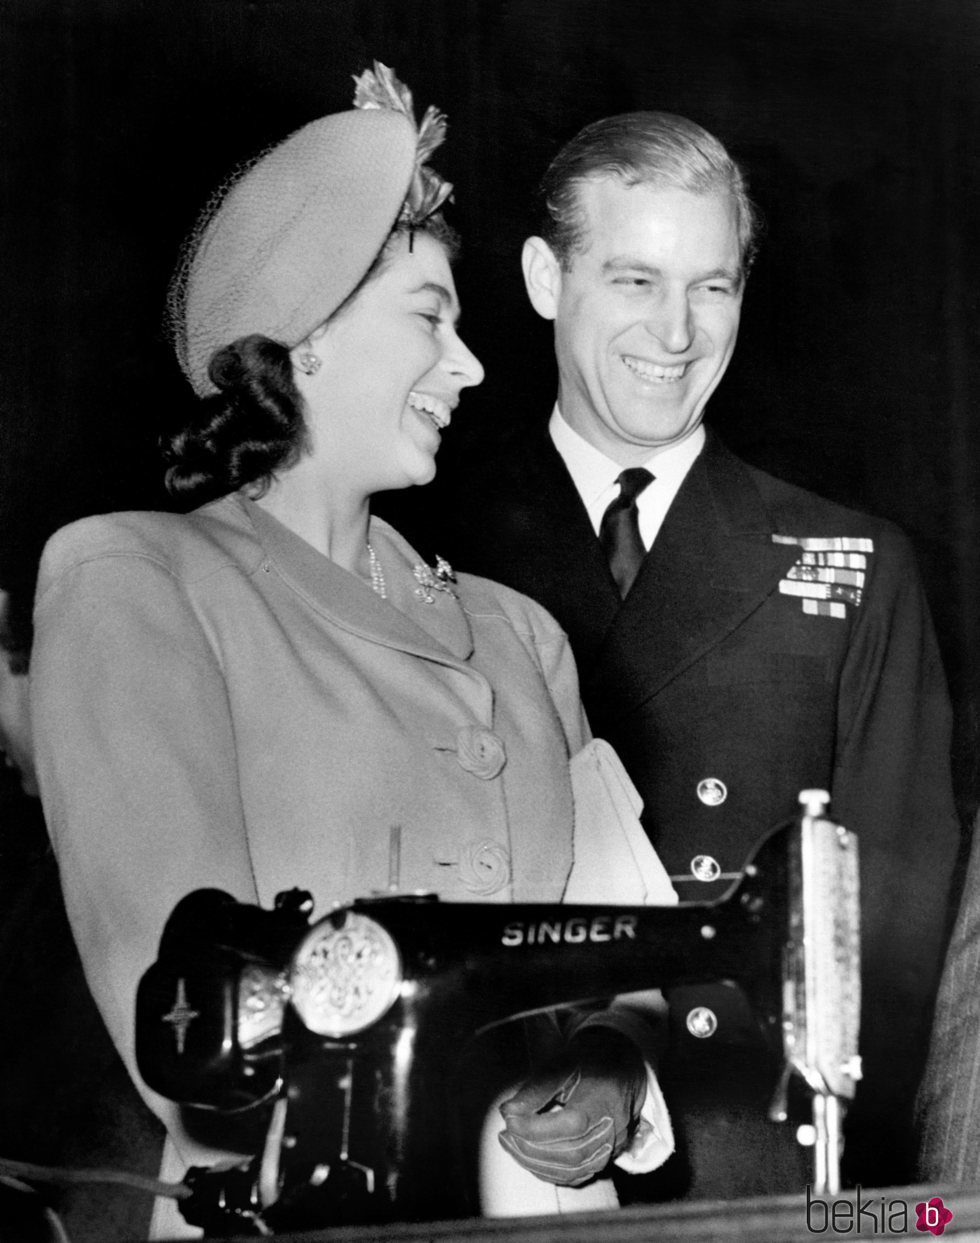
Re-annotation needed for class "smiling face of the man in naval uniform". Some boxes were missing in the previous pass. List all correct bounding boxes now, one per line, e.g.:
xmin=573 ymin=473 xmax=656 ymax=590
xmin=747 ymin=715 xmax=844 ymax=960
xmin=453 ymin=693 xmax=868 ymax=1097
xmin=525 ymin=178 xmax=742 ymax=466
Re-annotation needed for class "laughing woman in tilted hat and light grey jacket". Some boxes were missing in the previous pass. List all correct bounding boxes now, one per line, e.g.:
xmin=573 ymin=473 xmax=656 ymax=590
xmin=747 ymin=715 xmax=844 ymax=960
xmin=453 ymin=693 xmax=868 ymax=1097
xmin=26 ymin=55 xmax=672 ymax=1237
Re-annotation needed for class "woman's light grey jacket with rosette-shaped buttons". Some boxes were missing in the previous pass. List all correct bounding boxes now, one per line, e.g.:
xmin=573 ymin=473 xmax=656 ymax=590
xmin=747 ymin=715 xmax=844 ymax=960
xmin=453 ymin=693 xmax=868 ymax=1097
xmin=31 ymin=497 xmax=669 ymax=1233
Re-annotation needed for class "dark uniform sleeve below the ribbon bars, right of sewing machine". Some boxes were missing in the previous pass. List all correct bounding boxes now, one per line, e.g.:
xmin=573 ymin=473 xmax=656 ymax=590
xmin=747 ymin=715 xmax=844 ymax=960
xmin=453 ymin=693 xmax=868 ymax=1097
xmin=832 ymin=531 xmax=959 ymax=1148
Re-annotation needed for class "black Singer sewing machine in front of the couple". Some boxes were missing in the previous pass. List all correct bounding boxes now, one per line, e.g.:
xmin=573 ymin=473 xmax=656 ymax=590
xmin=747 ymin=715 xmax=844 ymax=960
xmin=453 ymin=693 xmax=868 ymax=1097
xmin=137 ymin=791 xmax=861 ymax=1233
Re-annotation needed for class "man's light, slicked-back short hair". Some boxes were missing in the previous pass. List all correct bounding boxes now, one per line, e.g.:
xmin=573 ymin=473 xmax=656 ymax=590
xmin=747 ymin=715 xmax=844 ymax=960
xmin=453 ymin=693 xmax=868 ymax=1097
xmin=539 ymin=112 xmax=760 ymax=276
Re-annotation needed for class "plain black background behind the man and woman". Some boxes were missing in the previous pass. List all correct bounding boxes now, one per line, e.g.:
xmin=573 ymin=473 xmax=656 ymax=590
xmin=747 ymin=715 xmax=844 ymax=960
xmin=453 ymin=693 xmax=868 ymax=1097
xmin=0 ymin=0 xmax=980 ymax=765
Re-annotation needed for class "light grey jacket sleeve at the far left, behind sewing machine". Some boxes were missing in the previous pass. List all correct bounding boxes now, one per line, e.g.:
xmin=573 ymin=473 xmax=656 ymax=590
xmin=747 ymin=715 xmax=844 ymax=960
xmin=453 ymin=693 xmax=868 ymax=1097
xmin=31 ymin=544 xmax=257 ymax=1114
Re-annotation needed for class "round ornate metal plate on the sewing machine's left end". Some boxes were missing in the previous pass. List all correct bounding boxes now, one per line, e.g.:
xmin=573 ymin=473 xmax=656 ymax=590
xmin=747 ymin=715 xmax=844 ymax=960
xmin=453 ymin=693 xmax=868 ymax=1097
xmin=290 ymin=911 xmax=402 ymax=1038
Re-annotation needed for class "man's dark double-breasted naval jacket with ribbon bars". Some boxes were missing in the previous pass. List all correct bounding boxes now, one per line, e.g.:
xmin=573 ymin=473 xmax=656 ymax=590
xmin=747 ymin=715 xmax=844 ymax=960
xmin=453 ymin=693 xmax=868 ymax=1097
xmin=417 ymin=425 xmax=959 ymax=1195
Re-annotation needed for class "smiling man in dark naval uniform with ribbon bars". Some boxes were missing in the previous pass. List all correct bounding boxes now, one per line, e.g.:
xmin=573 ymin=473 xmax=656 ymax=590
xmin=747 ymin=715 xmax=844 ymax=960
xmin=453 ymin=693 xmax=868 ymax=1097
xmin=430 ymin=112 xmax=958 ymax=1195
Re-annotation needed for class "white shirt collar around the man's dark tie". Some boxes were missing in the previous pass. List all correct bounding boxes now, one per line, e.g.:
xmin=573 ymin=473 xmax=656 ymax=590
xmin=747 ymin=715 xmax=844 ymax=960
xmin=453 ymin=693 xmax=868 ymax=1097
xmin=548 ymin=404 xmax=705 ymax=548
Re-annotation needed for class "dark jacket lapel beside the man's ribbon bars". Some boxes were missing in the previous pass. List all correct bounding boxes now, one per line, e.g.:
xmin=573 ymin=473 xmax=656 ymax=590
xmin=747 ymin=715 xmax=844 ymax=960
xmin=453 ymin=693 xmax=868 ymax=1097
xmin=588 ymin=436 xmax=798 ymax=715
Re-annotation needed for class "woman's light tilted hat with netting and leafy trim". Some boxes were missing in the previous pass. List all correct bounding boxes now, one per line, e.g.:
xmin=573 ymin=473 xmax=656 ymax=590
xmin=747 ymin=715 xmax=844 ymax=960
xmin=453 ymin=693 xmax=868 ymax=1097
xmin=168 ymin=62 xmax=451 ymax=397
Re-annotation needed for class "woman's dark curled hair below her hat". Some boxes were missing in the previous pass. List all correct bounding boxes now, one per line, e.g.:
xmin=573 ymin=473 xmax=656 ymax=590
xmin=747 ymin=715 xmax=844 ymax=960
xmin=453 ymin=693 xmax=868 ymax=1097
xmin=163 ymin=336 xmax=307 ymax=505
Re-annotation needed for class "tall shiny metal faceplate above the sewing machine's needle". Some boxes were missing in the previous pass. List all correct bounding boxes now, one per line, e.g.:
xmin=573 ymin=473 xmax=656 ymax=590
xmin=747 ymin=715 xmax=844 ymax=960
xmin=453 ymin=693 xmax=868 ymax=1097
xmin=784 ymin=815 xmax=861 ymax=1098
